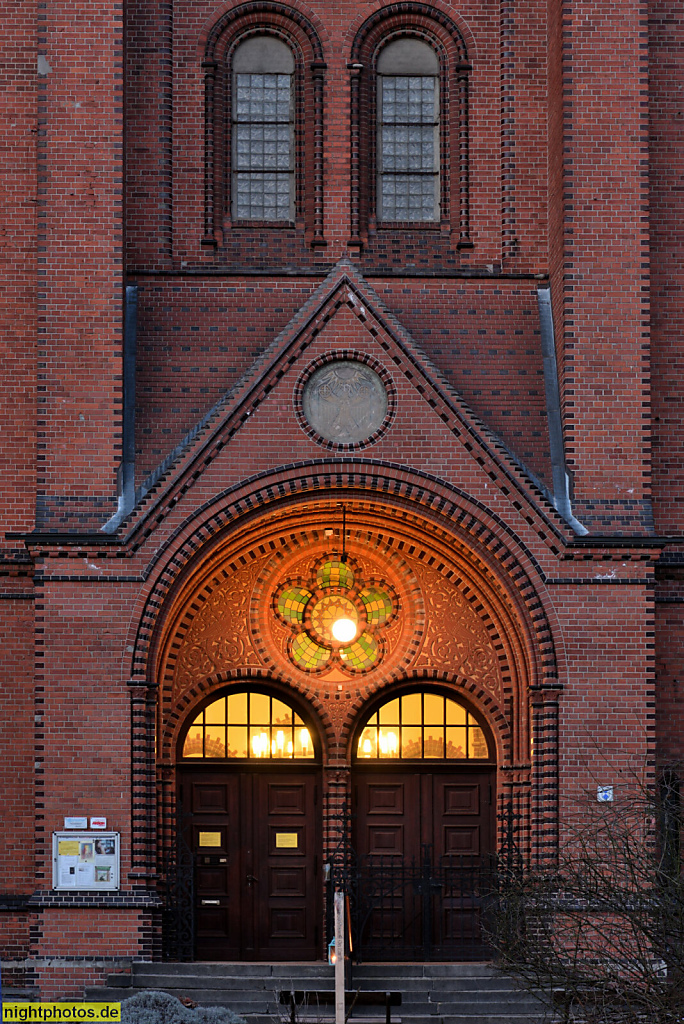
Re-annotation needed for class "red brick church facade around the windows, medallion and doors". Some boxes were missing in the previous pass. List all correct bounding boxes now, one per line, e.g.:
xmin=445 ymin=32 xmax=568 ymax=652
xmin=0 ymin=0 xmax=684 ymax=998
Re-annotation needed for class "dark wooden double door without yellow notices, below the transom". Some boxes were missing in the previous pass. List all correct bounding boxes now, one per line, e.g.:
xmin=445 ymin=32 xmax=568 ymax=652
xmin=353 ymin=766 xmax=495 ymax=961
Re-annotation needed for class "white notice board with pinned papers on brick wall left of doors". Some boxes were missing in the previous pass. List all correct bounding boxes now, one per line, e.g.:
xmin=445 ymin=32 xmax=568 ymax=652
xmin=52 ymin=831 xmax=120 ymax=892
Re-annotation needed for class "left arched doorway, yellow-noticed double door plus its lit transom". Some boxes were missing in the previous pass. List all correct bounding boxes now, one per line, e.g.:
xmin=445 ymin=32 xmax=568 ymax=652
xmin=177 ymin=684 xmax=322 ymax=961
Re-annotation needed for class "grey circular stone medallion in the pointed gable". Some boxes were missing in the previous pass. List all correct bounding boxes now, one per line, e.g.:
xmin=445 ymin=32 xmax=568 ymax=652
xmin=302 ymin=359 xmax=387 ymax=444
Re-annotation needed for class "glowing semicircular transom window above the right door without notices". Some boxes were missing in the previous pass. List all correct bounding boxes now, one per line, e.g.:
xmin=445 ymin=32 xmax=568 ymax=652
xmin=356 ymin=692 xmax=489 ymax=761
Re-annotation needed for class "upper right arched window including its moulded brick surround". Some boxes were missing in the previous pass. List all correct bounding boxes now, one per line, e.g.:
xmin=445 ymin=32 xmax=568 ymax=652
xmin=347 ymin=7 xmax=472 ymax=247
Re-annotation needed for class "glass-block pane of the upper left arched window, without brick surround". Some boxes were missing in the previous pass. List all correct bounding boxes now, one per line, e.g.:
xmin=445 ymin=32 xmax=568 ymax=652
xmin=231 ymin=36 xmax=295 ymax=221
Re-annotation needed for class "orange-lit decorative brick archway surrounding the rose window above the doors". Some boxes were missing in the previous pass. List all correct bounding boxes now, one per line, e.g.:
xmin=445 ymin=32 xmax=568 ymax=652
xmin=125 ymin=468 xmax=558 ymax=913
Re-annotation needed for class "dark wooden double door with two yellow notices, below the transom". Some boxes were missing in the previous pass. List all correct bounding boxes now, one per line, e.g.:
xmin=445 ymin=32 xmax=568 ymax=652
xmin=179 ymin=766 xmax=322 ymax=961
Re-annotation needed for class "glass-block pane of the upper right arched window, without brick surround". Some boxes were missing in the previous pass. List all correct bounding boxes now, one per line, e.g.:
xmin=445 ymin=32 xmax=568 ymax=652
xmin=376 ymin=37 xmax=439 ymax=221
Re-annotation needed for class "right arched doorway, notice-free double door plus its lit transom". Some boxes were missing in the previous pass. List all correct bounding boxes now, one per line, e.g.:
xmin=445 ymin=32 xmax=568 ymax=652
xmin=351 ymin=683 xmax=497 ymax=961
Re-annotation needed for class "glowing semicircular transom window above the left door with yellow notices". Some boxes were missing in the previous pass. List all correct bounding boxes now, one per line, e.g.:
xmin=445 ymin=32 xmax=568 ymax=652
xmin=182 ymin=692 xmax=315 ymax=761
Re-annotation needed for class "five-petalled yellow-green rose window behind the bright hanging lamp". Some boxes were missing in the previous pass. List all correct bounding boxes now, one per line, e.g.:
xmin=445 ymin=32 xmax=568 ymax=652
xmin=275 ymin=558 xmax=395 ymax=672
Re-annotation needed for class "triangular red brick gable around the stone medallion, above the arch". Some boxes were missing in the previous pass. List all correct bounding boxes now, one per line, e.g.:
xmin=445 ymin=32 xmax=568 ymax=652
xmin=117 ymin=259 xmax=573 ymax=544
